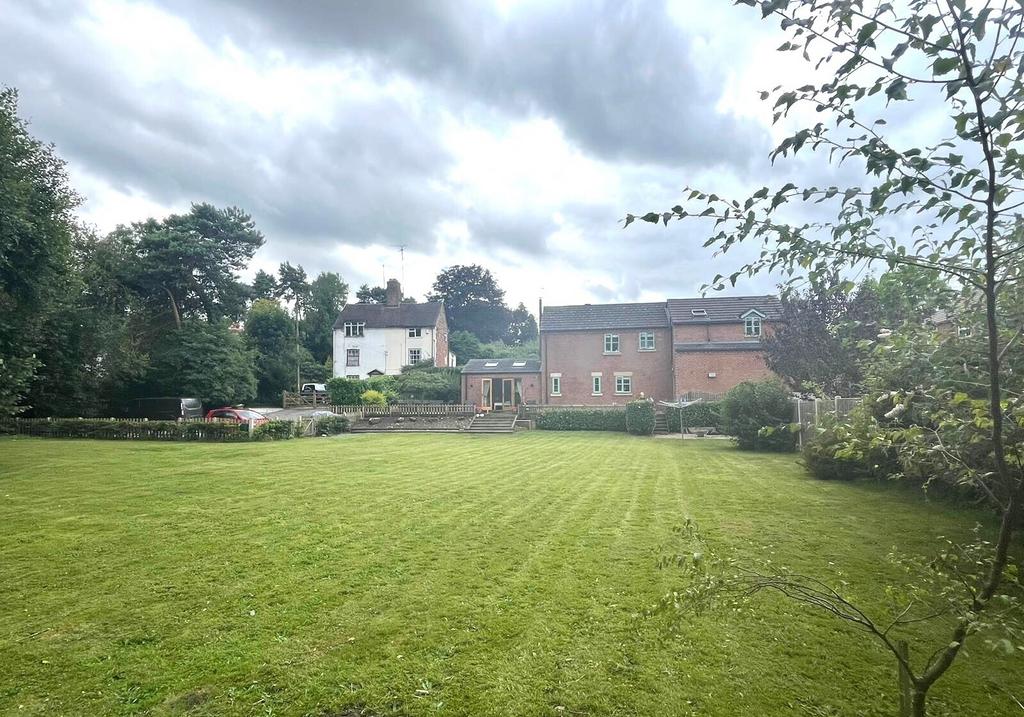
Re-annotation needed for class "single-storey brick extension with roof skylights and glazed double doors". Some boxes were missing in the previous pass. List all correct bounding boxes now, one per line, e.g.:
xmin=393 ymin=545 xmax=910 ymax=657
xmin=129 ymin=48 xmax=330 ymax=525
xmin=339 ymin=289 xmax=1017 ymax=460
xmin=462 ymin=359 xmax=543 ymax=411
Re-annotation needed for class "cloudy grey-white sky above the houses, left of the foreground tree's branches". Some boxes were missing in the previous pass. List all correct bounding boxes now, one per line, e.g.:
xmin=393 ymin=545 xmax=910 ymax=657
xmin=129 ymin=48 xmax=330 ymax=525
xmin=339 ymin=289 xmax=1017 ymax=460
xmin=0 ymin=0 xmax=847 ymax=307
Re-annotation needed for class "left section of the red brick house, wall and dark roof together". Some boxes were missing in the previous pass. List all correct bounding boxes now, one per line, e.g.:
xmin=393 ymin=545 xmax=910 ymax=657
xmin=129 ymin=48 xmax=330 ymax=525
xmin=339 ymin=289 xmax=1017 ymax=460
xmin=541 ymin=301 xmax=673 ymax=406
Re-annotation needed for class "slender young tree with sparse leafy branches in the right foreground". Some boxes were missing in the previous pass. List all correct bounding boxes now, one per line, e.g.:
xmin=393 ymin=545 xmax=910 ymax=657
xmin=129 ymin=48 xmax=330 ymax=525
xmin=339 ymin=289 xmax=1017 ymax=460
xmin=626 ymin=0 xmax=1024 ymax=717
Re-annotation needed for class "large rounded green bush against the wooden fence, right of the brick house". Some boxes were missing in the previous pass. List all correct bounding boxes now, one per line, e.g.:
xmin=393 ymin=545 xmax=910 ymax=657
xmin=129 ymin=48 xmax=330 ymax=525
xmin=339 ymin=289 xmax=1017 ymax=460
xmin=721 ymin=381 xmax=797 ymax=451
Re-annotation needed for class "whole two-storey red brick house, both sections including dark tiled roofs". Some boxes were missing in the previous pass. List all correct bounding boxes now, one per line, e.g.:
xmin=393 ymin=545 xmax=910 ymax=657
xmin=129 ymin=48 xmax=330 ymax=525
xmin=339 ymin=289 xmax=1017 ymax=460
xmin=540 ymin=296 xmax=781 ymax=406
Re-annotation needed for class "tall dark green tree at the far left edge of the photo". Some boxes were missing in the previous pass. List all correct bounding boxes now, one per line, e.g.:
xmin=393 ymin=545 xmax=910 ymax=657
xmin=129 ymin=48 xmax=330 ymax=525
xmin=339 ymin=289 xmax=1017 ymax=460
xmin=0 ymin=88 xmax=79 ymax=416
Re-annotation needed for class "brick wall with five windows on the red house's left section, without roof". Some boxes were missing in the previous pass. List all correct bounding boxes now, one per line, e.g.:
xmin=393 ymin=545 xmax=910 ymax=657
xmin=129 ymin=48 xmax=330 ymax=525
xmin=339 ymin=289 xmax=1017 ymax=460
xmin=541 ymin=328 xmax=673 ymax=406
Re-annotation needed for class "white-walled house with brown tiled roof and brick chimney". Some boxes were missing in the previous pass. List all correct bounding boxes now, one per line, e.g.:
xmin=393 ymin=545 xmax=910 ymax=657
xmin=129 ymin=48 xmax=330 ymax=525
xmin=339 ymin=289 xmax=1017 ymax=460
xmin=334 ymin=279 xmax=455 ymax=379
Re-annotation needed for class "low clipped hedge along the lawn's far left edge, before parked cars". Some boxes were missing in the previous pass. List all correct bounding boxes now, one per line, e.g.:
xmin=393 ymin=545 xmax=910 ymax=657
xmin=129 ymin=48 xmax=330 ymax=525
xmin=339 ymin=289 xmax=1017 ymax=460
xmin=0 ymin=416 xmax=349 ymax=442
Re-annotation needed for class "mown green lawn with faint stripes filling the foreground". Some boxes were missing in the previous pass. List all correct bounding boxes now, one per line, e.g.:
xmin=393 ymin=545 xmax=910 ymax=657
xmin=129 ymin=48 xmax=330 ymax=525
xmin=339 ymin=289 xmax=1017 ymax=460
xmin=0 ymin=432 xmax=1024 ymax=717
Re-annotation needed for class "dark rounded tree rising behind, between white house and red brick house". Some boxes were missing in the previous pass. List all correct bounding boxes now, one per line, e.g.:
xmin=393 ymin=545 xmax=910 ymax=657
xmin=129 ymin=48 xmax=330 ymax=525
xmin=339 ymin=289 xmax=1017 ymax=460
xmin=428 ymin=264 xmax=511 ymax=342
